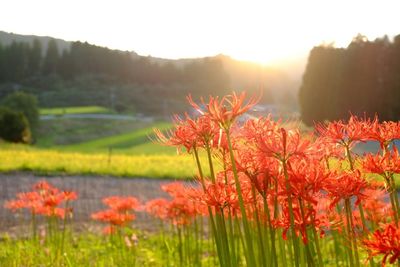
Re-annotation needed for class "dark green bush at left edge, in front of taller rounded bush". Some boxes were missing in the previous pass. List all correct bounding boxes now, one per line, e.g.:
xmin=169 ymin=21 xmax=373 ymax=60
xmin=0 ymin=107 xmax=31 ymax=143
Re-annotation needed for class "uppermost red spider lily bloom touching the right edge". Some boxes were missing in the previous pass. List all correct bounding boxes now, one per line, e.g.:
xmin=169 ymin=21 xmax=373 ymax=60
xmin=368 ymin=117 xmax=400 ymax=149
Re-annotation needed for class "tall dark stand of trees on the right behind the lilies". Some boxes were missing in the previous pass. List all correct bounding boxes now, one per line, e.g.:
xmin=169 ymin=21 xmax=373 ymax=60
xmin=299 ymin=35 xmax=400 ymax=125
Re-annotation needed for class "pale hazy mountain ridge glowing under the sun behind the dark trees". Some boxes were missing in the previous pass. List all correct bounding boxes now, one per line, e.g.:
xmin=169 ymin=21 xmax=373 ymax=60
xmin=0 ymin=31 xmax=306 ymax=102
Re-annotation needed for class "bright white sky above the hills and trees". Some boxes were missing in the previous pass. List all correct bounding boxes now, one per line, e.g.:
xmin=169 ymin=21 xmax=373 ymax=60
xmin=0 ymin=0 xmax=400 ymax=65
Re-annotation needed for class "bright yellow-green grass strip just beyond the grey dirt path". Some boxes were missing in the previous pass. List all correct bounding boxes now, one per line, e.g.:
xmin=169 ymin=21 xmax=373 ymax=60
xmin=0 ymin=144 xmax=202 ymax=179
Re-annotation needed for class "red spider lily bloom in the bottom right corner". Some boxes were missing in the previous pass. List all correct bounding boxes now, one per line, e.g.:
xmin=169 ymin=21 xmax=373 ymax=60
xmin=362 ymin=223 xmax=400 ymax=266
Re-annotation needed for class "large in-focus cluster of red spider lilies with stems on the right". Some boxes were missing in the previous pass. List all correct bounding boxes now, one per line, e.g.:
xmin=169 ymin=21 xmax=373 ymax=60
xmin=155 ymin=93 xmax=400 ymax=265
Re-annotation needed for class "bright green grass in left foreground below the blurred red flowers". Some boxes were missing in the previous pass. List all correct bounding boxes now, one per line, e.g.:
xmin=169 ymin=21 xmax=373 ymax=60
xmin=0 ymin=227 xmax=216 ymax=267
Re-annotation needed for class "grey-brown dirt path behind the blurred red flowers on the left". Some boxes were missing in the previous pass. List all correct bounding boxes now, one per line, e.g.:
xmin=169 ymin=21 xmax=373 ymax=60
xmin=0 ymin=173 xmax=181 ymax=230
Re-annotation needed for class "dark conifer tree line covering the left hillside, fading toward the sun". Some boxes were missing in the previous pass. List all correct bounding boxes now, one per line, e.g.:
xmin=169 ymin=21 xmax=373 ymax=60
xmin=0 ymin=39 xmax=230 ymax=113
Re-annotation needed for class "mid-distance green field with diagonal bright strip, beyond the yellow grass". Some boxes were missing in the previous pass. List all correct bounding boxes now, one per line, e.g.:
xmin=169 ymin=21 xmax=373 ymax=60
xmin=35 ymin=119 xmax=176 ymax=155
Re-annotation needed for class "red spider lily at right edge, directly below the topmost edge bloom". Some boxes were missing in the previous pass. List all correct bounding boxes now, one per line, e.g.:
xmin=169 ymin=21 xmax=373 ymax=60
xmin=362 ymin=147 xmax=400 ymax=176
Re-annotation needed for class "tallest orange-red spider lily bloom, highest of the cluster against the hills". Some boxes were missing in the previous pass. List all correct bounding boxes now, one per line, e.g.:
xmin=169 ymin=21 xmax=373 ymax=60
xmin=187 ymin=92 xmax=258 ymax=130
